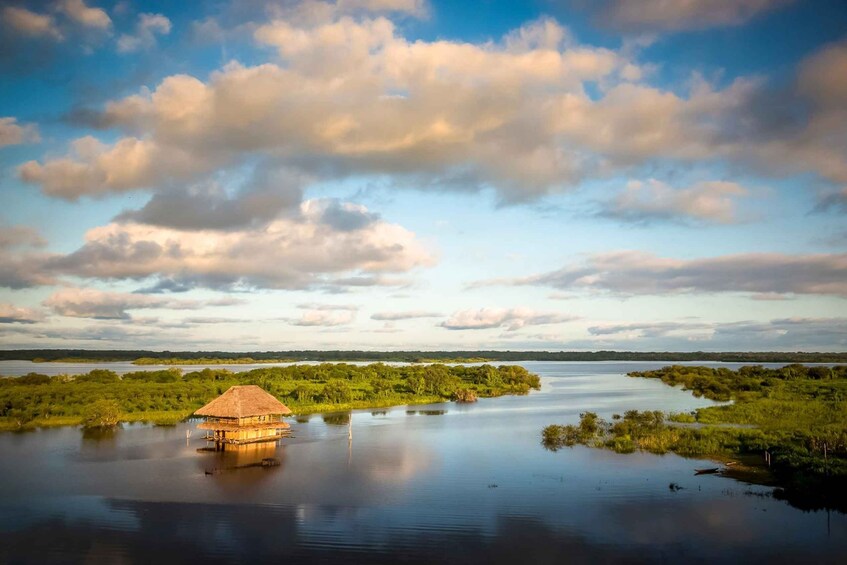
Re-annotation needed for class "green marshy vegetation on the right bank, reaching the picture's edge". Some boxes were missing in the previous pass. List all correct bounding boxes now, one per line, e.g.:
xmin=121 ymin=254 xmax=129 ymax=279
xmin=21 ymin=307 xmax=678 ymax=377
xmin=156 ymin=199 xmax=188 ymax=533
xmin=542 ymin=365 xmax=847 ymax=512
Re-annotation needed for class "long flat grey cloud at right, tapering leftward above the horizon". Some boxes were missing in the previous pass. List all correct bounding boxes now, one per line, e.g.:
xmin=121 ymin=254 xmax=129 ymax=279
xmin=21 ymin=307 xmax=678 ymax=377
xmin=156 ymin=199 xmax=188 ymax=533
xmin=494 ymin=251 xmax=847 ymax=297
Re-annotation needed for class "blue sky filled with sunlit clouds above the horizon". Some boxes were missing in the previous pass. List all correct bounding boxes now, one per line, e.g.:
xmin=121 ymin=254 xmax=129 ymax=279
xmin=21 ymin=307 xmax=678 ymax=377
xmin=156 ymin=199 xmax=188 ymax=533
xmin=0 ymin=0 xmax=847 ymax=351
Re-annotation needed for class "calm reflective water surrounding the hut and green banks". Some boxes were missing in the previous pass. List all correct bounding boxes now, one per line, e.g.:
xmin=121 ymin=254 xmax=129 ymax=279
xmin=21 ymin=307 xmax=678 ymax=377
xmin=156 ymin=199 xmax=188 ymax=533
xmin=0 ymin=362 xmax=847 ymax=564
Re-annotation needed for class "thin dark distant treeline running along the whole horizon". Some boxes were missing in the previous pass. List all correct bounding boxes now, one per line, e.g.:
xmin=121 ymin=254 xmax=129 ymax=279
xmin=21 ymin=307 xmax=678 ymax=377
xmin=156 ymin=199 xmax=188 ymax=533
xmin=6 ymin=349 xmax=847 ymax=363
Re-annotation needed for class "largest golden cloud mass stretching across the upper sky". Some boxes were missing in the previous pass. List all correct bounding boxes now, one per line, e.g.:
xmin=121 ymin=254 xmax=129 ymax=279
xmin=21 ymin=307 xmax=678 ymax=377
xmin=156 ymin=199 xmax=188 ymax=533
xmin=19 ymin=16 xmax=847 ymax=205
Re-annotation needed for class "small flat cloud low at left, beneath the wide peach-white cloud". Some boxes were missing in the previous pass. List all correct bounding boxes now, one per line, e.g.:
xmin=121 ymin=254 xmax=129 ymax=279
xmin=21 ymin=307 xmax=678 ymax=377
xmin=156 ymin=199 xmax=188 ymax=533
xmin=43 ymin=288 xmax=238 ymax=320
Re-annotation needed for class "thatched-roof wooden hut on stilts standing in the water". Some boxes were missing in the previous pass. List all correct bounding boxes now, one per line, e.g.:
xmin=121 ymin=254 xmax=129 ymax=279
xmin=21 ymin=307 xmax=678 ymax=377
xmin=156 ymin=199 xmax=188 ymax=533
xmin=194 ymin=385 xmax=291 ymax=445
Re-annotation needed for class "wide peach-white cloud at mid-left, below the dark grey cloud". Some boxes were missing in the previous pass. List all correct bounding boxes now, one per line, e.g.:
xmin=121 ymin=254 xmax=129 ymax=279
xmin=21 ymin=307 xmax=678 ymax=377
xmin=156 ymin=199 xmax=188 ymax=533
xmin=34 ymin=201 xmax=433 ymax=289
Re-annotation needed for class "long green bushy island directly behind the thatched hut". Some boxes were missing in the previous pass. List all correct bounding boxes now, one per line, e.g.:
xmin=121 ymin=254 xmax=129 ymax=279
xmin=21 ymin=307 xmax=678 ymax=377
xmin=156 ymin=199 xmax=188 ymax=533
xmin=0 ymin=363 xmax=541 ymax=431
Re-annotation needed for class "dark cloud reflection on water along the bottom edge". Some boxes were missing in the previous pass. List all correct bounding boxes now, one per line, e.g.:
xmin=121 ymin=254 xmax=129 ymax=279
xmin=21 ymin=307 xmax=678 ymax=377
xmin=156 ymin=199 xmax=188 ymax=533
xmin=0 ymin=499 xmax=836 ymax=564
